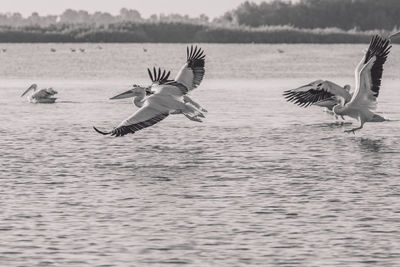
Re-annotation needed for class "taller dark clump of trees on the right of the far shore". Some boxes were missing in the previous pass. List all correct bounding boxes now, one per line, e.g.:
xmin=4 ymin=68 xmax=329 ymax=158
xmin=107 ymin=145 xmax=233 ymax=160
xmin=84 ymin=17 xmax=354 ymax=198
xmin=220 ymin=0 xmax=400 ymax=31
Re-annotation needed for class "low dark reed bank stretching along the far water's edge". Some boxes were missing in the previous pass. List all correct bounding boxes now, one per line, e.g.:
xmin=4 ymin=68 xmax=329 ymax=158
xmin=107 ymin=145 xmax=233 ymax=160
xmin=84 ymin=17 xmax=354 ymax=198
xmin=0 ymin=23 xmax=400 ymax=44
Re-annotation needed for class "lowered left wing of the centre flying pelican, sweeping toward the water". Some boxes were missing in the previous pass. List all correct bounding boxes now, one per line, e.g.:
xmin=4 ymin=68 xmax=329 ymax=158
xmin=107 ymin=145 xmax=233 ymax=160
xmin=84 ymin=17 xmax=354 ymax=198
xmin=93 ymin=104 xmax=169 ymax=137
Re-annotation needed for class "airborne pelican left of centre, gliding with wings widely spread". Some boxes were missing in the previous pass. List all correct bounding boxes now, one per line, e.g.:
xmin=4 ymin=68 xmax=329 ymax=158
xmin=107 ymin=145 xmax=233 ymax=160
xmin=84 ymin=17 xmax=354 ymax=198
xmin=93 ymin=46 xmax=205 ymax=136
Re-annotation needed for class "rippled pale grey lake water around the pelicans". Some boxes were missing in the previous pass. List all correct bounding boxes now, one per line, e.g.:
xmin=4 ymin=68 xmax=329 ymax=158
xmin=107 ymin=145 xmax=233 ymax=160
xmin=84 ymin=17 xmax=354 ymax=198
xmin=0 ymin=44 xmax=400 ymax=266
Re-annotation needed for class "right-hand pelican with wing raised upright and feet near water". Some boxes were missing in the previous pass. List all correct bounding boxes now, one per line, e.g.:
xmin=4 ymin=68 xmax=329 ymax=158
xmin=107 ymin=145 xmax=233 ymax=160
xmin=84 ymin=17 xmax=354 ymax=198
xmin=284 ymin=32 xmax=400 ymax=133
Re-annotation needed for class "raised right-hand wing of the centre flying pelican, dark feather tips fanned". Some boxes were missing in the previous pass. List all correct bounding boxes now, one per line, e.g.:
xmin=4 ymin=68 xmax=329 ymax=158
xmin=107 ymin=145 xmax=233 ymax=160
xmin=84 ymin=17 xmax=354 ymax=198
xmin=175 ymin=46 xmax=206 ymax=94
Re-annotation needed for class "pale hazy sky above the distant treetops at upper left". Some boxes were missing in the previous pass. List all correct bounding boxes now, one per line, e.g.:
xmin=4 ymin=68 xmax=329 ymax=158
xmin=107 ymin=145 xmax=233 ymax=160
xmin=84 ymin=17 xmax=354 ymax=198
xmin=0 ymin=0 xmax=268 ymax=18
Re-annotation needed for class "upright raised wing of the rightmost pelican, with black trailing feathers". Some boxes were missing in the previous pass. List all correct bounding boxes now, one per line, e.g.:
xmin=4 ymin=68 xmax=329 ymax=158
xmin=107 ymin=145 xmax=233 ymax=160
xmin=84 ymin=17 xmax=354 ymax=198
xmin=348 ymin=35 xmax=392 ymax=109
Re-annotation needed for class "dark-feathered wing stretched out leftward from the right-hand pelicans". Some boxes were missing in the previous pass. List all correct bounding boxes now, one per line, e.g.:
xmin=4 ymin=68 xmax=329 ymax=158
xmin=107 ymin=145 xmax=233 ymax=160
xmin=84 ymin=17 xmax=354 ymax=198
xmin=283 ymin=82 xmax=350 ymax=107
